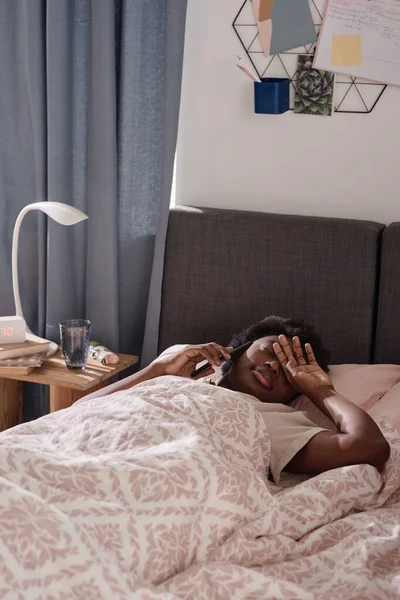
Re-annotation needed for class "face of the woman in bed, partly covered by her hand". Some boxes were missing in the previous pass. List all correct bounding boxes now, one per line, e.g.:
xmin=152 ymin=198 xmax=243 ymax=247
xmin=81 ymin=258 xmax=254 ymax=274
xmin=224 ymin=335 xmax=296 ymax=404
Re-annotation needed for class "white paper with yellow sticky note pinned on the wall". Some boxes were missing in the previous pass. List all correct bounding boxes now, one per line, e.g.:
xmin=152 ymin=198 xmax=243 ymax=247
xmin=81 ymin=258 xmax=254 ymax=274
xmin=314 ymin=0 xmax=400 ymax=85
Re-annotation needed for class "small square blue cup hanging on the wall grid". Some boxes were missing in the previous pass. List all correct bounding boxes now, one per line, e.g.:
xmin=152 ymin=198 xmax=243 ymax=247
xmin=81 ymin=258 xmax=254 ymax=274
xmin=254 ymin=77 xmax=290 ymax=115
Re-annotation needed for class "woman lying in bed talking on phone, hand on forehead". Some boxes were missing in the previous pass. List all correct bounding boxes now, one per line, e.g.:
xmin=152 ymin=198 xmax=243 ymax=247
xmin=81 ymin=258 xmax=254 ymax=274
xmin=86 ymin=317 xmax=390 ymax=483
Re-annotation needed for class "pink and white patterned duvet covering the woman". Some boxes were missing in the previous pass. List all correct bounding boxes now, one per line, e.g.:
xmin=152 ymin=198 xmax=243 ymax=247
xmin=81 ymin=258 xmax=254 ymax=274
xmin=0 ymin=377 xmax=400 ymax=600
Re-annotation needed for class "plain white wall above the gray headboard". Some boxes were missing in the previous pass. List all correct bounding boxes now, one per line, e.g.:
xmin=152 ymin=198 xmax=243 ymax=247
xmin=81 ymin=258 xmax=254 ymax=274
xmin=176 ymin=0 xmax=400 ymax=223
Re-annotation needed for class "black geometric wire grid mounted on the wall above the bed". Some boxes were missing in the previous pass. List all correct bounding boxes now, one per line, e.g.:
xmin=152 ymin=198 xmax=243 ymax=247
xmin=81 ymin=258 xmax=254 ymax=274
xmin=232 ymin=0 xmax=387 ymax=114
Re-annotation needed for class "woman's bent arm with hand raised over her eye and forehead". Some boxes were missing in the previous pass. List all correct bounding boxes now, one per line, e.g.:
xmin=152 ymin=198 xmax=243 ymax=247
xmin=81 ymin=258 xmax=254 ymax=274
xmin=274 ymin=336 xmax=390 ymax=473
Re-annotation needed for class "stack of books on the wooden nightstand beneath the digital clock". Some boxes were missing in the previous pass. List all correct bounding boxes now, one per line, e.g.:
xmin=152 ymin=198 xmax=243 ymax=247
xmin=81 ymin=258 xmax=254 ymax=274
xmin=0 ymin=341 xmax=49 ymax=377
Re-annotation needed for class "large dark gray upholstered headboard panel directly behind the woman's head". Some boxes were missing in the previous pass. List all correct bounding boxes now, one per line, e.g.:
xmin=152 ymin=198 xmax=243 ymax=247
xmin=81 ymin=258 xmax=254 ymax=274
xmin=159 ymin=207 xmax=384 ymax=363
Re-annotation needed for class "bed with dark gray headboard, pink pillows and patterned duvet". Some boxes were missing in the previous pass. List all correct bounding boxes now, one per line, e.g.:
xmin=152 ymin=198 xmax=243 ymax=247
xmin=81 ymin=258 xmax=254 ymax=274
xmin=0 ymin=208 xmax=400 ymax=600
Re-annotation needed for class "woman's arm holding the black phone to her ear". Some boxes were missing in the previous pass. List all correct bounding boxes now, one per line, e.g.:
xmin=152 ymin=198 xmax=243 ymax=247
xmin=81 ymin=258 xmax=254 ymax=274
xmin=81 ymin=342 xmax=232 ymax=400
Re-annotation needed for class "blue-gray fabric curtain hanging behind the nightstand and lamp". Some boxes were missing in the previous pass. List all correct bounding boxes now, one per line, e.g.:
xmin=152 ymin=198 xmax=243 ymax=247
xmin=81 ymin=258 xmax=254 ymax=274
xmin=0 ymin=0 xmax=186 ymax=420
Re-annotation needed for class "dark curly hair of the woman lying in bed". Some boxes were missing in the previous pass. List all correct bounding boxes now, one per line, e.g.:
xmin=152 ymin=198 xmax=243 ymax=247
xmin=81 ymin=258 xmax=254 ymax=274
xmin=222 ymin=316 xmax=329 ymax=375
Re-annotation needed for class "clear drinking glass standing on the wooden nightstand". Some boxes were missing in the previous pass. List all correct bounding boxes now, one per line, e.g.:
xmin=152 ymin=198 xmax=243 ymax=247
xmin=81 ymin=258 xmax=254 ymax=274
xmin=60 ymin=319 xmax=92 ymax=371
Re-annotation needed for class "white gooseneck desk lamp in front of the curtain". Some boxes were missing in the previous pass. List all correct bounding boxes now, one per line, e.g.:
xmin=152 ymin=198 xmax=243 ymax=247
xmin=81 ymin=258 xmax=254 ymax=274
xmin=7 ymin=202 xmax=88 ymax=356
